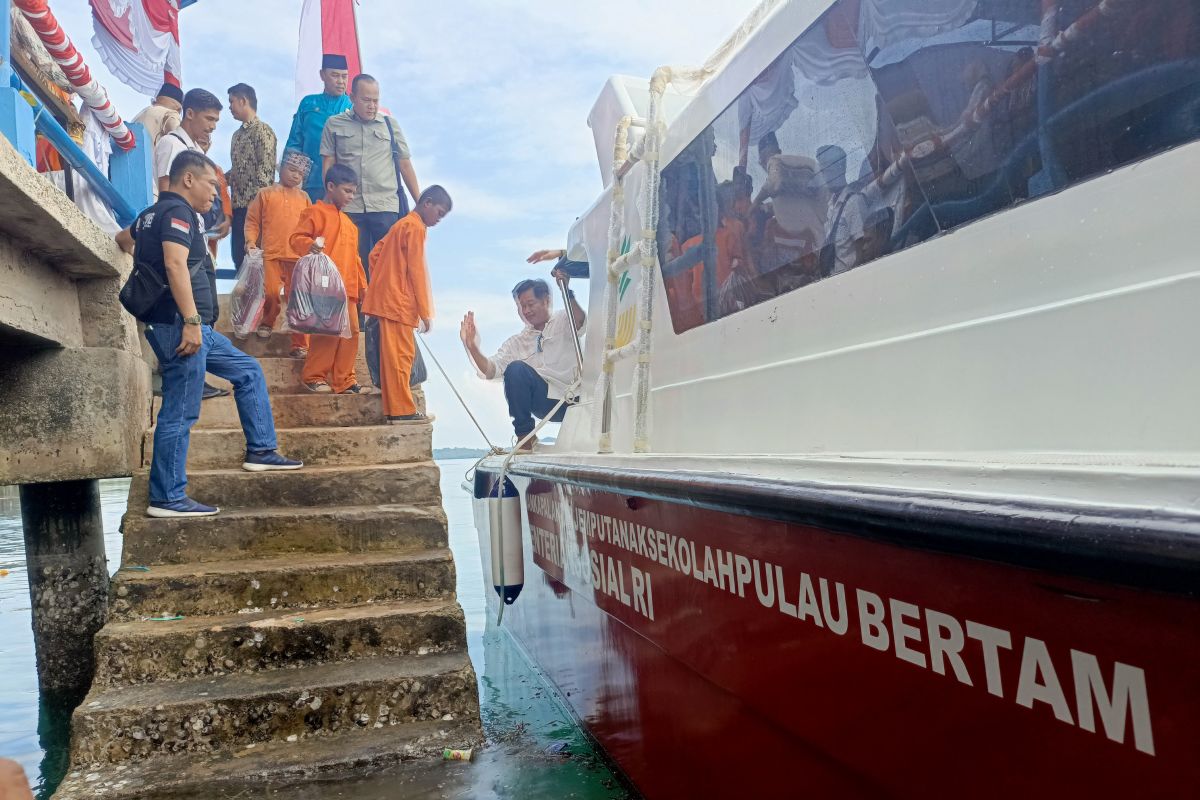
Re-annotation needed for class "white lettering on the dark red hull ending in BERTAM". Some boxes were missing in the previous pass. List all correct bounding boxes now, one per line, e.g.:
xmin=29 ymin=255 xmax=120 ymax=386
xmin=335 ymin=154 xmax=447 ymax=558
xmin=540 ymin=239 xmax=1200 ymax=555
xmin=549 ymin=503 xmax=1154 ymax=756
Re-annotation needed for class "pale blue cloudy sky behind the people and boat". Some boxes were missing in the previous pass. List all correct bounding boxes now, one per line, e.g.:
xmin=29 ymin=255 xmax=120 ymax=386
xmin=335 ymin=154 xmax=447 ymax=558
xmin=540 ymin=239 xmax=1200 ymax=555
xmin=50 ymin=0 xmax=757 ymax=447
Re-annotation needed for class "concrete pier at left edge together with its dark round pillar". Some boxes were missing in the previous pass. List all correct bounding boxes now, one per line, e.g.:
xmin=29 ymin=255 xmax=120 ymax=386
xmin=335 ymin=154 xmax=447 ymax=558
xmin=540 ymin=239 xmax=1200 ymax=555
xmin=0 ymin=134 xmax=151 ymax=694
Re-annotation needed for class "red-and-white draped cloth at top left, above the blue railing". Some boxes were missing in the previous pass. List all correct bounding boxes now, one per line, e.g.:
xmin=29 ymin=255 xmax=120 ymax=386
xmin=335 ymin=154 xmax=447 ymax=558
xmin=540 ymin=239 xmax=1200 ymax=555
xmin=89 ymin=0 xmax=184 ymax=97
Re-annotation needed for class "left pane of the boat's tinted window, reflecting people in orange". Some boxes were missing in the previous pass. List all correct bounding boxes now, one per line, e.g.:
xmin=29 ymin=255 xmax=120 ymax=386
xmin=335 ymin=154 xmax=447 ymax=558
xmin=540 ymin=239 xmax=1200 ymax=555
xmin=660 ymin=6 xmax=937 ymax=331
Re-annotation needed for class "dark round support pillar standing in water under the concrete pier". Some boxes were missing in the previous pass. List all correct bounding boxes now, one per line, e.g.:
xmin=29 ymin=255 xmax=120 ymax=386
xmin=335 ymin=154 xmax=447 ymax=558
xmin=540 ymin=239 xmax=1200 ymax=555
xmin=20 ymin=480 xmax=108 ymax=692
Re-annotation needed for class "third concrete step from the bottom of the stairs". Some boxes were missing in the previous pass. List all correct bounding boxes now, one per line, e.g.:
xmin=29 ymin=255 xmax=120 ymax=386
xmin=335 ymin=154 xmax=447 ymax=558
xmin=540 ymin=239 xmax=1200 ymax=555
xmin=92 ymin=600 xmax=467 ymax=686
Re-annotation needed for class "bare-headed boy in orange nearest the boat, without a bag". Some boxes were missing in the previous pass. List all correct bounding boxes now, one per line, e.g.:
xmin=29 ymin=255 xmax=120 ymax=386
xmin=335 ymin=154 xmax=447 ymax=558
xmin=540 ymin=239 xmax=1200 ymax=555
xmin=362 ymin=186 xmax=454 ymax=423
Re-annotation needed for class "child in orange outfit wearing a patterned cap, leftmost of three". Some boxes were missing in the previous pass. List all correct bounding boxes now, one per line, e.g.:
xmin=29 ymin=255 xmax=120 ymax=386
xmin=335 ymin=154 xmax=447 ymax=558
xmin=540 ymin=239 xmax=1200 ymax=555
xmin=246 ymin=150 xmax=312 ymax=359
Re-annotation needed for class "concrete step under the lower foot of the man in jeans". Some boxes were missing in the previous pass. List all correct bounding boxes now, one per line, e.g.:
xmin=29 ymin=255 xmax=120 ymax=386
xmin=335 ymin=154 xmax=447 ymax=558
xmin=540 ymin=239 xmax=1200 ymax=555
xmin=121 ymin=505 xmax=448 ymax=566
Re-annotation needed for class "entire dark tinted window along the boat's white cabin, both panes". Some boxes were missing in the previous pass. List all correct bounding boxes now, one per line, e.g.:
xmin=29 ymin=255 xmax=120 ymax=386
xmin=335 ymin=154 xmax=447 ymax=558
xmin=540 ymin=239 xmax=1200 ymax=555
xmin=659 ymin=0 xmax=1200 ymax=332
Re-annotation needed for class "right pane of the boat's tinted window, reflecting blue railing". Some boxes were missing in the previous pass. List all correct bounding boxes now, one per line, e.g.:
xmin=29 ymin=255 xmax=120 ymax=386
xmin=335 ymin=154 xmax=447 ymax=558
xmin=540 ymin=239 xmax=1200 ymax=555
xmin=860 ymin=0 xmax=1200 ymax=229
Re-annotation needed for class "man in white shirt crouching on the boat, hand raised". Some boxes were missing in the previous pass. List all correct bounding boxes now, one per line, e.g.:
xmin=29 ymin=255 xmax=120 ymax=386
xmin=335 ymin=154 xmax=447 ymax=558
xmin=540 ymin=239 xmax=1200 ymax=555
xmin=458 ymin=270 xmax=587 ymax=451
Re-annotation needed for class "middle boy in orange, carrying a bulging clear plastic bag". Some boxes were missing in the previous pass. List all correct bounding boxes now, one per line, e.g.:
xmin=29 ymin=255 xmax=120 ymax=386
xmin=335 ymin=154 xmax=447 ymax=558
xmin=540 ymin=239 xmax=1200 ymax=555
xmin=290 ymin=164 xmax=374 ymax=395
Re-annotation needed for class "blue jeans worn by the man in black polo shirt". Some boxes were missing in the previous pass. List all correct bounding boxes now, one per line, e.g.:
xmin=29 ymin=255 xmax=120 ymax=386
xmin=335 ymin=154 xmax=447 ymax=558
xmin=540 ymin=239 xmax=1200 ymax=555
xmin=146 ymin=318 xmax=278 ymax=503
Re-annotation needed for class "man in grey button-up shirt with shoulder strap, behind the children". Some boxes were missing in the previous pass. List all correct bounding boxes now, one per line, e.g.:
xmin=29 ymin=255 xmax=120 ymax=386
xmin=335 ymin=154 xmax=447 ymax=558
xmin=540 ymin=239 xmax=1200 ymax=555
xmin=320 ymin=73 xmax=425 ymax=386
